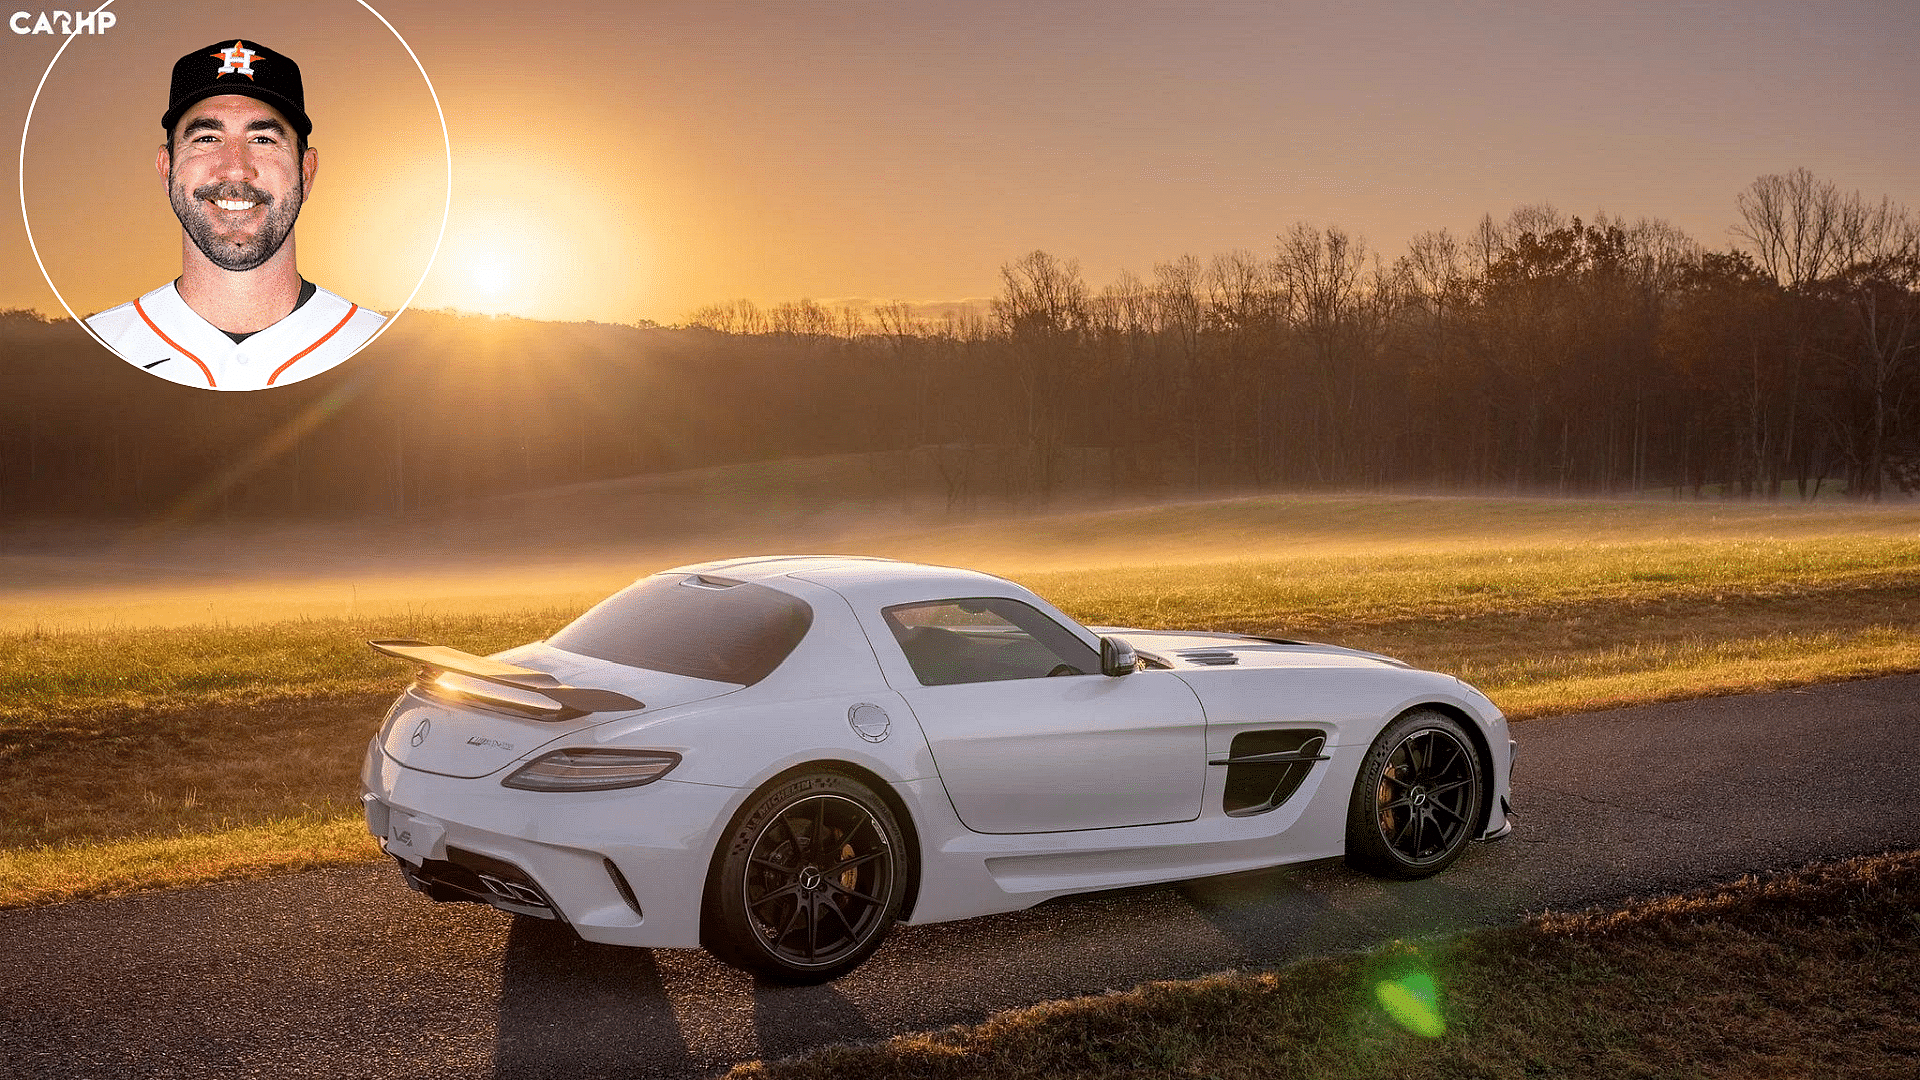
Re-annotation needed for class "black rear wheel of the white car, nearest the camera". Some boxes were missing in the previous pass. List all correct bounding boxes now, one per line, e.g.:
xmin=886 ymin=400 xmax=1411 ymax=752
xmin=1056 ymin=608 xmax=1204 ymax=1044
xmin=703 ymin=771 xmax=912 ymax=984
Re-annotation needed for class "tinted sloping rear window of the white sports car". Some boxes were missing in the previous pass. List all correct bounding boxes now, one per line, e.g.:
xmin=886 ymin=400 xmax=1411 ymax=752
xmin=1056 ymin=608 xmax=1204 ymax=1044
xmin=547 ymin=575 xmax=814 ymax=686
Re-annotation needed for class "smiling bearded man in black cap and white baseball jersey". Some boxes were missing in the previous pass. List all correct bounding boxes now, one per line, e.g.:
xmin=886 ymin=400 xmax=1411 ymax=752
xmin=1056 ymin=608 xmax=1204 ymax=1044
xmin=86 ymin=38 xmax=386 ymax=390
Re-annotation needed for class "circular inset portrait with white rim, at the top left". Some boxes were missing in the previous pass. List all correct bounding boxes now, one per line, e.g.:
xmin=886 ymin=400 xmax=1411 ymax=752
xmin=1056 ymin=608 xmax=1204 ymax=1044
xmin=21 ymin=0 xmax=451 ymax=390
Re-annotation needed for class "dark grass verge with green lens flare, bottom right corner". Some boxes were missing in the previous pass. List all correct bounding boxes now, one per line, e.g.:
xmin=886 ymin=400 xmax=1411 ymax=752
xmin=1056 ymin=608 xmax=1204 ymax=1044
xmin=730 ymin=853 xmax=1920 ymax=1080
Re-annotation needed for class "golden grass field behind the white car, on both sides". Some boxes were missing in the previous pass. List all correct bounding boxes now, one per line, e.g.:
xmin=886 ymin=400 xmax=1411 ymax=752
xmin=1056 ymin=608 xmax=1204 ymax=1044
xmin=0 ymin=496 xmax=1920 ymax=905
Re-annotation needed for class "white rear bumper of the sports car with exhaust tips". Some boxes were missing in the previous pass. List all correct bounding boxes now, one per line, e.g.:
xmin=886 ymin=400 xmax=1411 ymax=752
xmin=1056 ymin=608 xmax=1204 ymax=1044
xmin=361 ymin=734 xmax=743 ymax=947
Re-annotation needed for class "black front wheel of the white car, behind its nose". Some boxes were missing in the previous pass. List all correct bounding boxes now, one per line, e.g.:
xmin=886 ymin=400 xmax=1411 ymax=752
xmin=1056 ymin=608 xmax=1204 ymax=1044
xmin=1346 ymin=709 xmax=1486 ymax=880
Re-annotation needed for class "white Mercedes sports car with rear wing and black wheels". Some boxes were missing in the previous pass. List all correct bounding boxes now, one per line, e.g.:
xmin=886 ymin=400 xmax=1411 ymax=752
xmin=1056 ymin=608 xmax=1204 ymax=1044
xmin=363 ymin=555 xmax=1513 ymax=982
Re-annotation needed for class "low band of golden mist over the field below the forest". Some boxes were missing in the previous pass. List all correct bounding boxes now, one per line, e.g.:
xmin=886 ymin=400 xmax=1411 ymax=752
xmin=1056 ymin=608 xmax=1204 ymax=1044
xmin=0 ymin=468 xmax=1920 ymax=632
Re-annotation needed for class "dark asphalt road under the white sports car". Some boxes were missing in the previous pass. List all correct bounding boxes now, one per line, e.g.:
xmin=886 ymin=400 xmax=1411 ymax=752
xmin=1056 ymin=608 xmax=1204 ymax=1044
xmin=0 ymin=675 xmax=1920 ymax=1080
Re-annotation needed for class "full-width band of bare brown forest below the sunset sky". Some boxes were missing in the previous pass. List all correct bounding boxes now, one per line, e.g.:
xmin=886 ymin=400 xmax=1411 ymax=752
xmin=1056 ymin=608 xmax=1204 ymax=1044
xmin=0 ymin=169 xmax=1920 ymax=521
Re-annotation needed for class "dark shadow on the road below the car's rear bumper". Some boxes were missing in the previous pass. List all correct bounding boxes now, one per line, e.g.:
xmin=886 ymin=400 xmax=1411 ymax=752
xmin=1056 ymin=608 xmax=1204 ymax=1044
xmin=493 ymin=919 xmax=701 ymax=1080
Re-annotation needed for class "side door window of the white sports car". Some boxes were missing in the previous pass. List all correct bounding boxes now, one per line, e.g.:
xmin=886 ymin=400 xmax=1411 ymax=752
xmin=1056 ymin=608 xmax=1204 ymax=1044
xmin=881 ymin=596 xmax=1100 ymax=686
